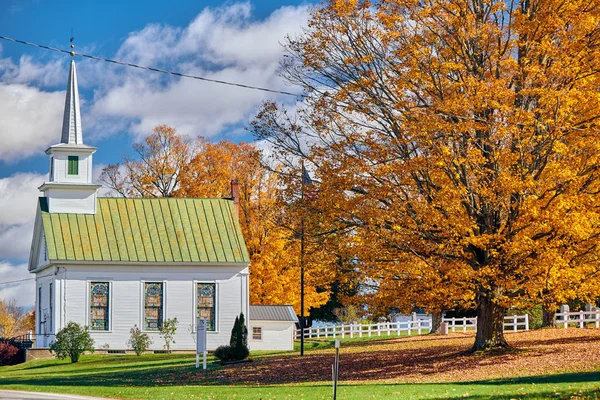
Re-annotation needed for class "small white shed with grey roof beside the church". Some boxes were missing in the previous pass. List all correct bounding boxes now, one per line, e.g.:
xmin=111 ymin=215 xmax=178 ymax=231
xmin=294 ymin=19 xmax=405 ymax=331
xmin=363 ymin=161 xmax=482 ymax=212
xmin=248 ymin=304 xmax=298 ymax=350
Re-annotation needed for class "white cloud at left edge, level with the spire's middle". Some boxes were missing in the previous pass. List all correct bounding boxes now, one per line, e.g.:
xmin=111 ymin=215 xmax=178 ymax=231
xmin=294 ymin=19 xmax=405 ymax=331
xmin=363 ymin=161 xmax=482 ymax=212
xmin=0 ymin=83 xmax=65 ymax=161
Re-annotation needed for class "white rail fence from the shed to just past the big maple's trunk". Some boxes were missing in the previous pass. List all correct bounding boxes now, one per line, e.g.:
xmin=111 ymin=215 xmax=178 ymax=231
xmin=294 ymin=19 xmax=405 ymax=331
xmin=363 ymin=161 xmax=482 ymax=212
xmin=296 ymin=314 xmax=529 ymax=339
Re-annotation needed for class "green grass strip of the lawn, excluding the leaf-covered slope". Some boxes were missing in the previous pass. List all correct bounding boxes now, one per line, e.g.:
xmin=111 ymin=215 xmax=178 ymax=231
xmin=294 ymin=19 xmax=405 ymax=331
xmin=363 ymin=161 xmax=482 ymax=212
xmin=0 ymin=354 xmax=600 ymax=400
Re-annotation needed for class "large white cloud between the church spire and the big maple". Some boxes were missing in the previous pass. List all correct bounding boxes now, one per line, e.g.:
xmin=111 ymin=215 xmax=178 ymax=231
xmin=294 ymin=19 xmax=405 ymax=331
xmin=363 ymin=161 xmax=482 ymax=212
xmin=92 ymin=3 xmax=309 ymax=137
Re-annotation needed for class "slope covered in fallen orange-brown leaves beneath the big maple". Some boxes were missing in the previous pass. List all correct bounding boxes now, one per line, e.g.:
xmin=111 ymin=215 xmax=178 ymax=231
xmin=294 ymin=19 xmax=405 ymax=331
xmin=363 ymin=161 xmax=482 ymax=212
xmin=204 ymin=329 xmax=600 ymax=384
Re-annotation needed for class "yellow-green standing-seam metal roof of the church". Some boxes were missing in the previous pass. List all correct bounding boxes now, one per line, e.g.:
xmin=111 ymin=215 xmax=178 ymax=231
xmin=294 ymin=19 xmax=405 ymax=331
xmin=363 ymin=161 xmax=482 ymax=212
xmin=40 ymin=197 xmax=250 ymax=263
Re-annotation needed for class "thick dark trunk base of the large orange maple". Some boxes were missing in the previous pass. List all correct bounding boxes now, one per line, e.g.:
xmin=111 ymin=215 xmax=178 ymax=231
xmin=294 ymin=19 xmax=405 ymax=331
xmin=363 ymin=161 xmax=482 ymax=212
xmin=471 ymin=292 xmax=509 ymax=352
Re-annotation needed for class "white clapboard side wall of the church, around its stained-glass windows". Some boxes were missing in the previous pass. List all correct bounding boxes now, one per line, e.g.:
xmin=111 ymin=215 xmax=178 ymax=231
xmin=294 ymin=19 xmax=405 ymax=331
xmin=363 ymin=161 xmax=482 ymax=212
xmin=37 ymin=265 xmax=248 ymax=350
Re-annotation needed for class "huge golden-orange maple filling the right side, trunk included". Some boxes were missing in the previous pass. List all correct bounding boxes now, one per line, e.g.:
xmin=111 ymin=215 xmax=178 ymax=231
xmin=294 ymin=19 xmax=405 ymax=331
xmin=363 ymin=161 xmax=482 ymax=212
xmin=255 ymin=0 xmax=600 ymax=350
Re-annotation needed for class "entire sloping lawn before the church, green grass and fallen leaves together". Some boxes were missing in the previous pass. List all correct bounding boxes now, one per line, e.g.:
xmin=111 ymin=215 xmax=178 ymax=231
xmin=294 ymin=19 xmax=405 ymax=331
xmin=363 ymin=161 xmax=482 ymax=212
xmin=0 ymin=329 xmax=600 ymax=399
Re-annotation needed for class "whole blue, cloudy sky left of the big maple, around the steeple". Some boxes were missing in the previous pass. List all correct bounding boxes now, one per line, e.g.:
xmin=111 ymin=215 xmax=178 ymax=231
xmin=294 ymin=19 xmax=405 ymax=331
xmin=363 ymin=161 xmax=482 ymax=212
xmin=0 ymin=0 xmax=311 ymax=305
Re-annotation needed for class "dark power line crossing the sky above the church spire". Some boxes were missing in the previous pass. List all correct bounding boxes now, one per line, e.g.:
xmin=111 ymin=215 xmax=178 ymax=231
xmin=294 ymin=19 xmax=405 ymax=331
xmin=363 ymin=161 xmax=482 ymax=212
xmin=0 ymin=35 xmax=302 ymax=98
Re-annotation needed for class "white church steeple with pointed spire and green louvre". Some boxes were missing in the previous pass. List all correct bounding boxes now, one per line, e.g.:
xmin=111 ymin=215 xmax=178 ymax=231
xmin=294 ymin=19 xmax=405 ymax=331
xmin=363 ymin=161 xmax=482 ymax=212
xmin=39 ymin=54 xmax=101 ymax=214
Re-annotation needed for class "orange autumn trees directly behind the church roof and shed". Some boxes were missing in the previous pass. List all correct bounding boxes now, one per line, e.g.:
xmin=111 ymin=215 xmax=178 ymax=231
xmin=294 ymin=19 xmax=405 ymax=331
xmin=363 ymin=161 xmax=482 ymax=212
xmin=101 ymin=125 xmax=328 ymax=312
